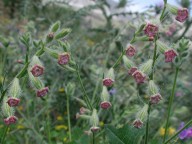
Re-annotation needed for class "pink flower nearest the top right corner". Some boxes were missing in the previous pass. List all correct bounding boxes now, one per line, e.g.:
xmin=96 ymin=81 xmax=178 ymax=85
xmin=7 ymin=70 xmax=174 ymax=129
xmin=175 ymin=8 xmax=189 ymax=22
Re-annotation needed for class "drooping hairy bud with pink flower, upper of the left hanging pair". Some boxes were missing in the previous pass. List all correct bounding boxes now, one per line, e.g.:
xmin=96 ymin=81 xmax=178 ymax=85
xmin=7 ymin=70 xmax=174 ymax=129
xmin=30 ymin=56 xmax=44 ymax=77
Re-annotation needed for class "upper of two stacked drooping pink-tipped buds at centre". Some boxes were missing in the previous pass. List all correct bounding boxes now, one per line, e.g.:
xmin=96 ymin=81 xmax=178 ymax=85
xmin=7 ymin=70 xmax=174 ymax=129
xmin=103 ymin=68 xmax=115 ymax=87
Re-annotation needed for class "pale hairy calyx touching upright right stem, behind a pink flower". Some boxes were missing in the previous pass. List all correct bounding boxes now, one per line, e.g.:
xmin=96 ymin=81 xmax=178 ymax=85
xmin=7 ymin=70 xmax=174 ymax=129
xmin=139 ymin=59 xmax=153 ymax=75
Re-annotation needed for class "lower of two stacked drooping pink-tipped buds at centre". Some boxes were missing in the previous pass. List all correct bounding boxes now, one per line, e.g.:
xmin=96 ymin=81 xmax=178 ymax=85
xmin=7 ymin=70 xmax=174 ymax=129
xmin=100 ymin=86 xmax=111 ymax=109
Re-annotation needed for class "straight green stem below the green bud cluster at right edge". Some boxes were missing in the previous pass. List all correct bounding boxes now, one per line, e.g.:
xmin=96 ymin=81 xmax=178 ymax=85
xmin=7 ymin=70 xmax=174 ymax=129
xmin=163 ymin=67 xmax=179 ymax=142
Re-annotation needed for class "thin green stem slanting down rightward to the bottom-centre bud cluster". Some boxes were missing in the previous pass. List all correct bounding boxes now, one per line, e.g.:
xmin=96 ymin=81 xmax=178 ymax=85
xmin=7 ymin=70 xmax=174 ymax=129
xmin=76 ymin=69 xmax=93 ymax=110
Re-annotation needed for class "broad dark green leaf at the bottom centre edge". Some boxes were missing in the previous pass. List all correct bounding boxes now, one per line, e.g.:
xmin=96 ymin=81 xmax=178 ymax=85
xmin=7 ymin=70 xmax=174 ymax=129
xmin=105 ymin=125 xmax=144 ymax=144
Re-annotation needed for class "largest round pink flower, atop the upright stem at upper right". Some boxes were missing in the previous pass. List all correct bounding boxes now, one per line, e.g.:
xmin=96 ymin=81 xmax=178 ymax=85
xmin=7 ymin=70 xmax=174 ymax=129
xmin=144 ymin=23 xmax=158 ymax=37
